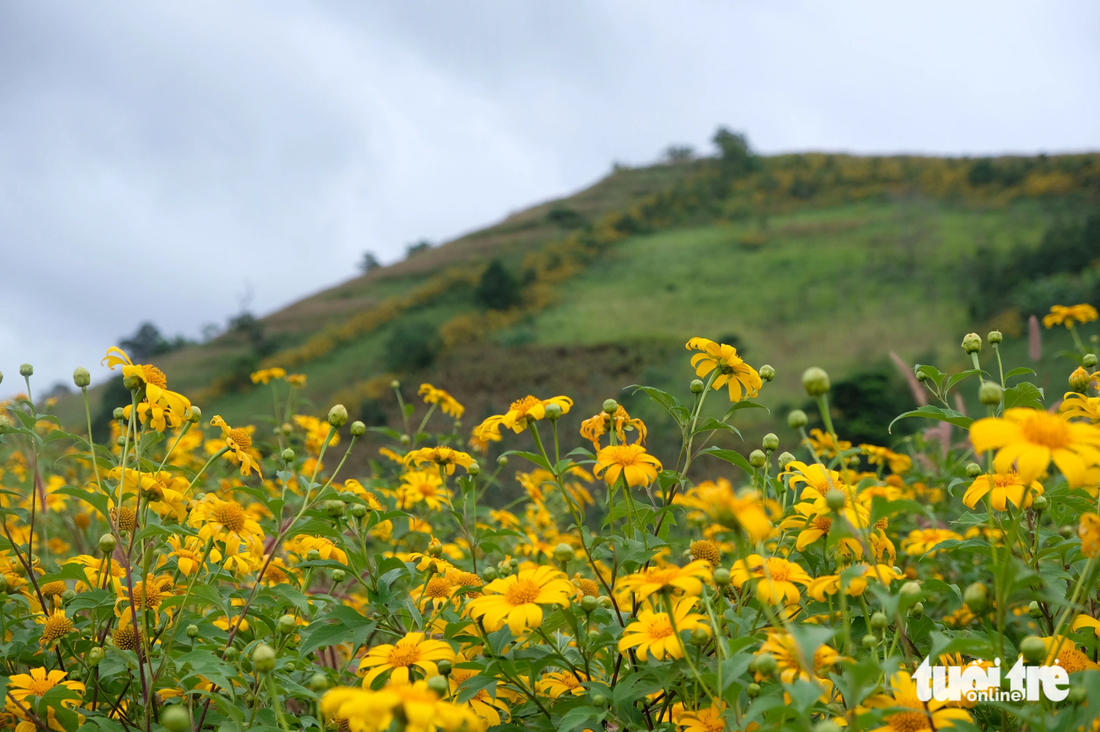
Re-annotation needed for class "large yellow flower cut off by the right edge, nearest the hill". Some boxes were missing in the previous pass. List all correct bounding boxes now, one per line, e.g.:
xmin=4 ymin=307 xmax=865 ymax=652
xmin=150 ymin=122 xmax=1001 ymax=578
xmin=970 ymin=407 xmax=1100 ymax=487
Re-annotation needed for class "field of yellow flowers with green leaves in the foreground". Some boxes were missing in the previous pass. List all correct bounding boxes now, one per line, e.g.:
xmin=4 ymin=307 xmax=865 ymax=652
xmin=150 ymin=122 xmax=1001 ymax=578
xmin=0 ymin=305 xmax=1100 ymax=732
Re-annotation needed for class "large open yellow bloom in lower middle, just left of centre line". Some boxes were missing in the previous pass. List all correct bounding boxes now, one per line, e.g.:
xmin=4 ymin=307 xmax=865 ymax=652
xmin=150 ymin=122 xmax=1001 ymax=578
xmin=466 ymin=567 xmax=574 ymax=635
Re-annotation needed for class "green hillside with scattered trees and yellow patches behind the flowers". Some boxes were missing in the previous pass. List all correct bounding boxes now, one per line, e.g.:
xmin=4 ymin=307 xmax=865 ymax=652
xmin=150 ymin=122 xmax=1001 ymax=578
xmin=59 ymin=145 xmax=1100 ymax=479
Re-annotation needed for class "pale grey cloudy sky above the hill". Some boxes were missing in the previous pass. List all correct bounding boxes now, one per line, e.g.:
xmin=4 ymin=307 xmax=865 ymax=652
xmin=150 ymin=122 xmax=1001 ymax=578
xmin=0 ymin=0 xmax=1100 ymax=394
